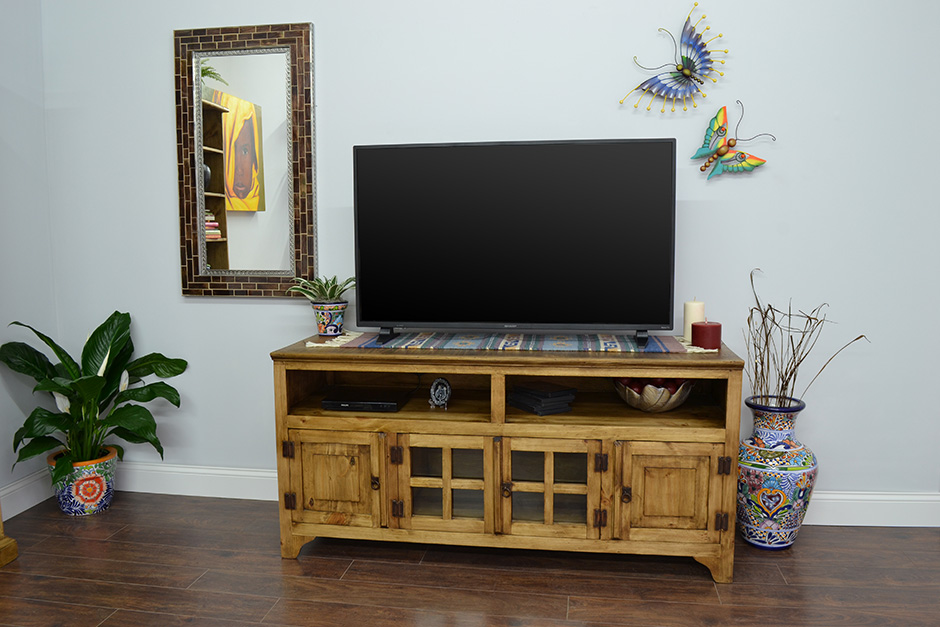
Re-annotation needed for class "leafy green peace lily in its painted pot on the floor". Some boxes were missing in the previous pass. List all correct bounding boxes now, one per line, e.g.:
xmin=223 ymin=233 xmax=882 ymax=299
xmin=0 ymin=311 xmax=187 ymax=515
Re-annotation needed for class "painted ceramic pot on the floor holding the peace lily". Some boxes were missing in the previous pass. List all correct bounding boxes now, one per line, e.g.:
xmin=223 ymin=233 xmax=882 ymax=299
xmin=46 ymin=446 xmax=117 ymax=516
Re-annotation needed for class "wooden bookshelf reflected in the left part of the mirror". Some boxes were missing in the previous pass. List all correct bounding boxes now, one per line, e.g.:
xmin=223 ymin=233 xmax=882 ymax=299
xmin=202 ymin=100 xmax=228 ymax=270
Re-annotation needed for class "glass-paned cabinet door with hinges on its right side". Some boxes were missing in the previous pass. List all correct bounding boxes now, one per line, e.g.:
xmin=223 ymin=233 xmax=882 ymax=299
xmin=499 ymin=438 xmax=611 ymax=539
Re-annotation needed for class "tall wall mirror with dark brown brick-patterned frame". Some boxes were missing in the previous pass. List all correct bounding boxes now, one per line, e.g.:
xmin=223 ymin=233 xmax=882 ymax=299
xmin=174 ymin=24 xmax=316 ymax=296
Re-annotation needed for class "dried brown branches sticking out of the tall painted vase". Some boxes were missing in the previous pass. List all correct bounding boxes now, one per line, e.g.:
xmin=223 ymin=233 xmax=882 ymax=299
xmin=745 ymin=268 xmax=868 ymax=406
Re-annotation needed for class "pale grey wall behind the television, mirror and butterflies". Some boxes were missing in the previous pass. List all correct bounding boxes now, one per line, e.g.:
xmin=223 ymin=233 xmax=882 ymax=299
xmin=0 ymin=0 xmax=940 ymax=524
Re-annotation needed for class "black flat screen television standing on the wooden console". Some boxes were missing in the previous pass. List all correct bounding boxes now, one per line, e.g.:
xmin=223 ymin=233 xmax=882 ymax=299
xmin=353 ymin=139 xmax=676 ymax=346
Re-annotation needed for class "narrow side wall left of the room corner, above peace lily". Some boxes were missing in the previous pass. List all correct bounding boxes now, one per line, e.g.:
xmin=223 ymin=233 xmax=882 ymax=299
xmin=0 ymin=0 xmax=63 ymax=517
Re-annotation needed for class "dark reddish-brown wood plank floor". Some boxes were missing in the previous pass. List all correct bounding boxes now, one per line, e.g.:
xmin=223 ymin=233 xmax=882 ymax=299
xmin=0 ymin=492 xmax=940 ymax=627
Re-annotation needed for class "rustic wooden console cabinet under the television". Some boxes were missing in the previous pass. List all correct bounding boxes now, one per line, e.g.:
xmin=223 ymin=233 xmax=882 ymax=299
xmin=271 ymin=338 xmax=743 ymax=582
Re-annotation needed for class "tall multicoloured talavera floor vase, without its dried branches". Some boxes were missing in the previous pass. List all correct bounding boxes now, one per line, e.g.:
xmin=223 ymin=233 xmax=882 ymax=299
xmin=738 ymin=396 xmax=817 ymax=549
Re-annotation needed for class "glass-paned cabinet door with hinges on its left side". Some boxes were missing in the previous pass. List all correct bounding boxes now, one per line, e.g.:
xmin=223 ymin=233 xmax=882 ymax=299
xmin=390 ymin=433 xmax=496 ymax=533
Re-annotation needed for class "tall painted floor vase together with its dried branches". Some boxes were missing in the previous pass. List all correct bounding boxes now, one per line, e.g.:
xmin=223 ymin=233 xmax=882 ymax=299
xmin=737 ymin=269 xmax=868 ymax=549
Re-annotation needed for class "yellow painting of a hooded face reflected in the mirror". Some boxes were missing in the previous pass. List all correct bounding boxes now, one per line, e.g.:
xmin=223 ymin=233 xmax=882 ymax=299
xmin=202 ymin=87 xmax=264 ymax=211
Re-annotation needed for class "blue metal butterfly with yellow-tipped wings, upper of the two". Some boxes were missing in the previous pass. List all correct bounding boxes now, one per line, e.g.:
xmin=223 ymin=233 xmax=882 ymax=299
xmin=620 ymin=2 xmax=728 ymax=113
